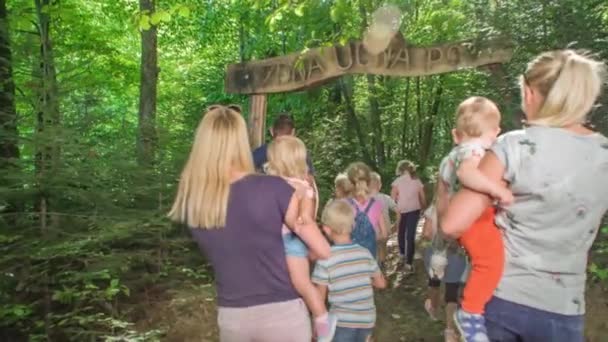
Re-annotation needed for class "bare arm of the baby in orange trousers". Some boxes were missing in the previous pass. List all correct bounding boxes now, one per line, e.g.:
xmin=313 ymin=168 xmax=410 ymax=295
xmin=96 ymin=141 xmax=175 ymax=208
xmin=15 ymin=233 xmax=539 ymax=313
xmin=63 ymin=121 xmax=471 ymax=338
xmin=456 ymin=156 xmax=513 ymax=204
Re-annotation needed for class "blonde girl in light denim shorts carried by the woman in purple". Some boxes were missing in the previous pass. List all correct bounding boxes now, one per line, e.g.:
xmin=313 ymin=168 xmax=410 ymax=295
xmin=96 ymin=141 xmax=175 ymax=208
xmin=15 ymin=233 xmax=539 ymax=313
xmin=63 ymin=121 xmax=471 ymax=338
xmin=267 ymin=135 xmax=337 ymax=342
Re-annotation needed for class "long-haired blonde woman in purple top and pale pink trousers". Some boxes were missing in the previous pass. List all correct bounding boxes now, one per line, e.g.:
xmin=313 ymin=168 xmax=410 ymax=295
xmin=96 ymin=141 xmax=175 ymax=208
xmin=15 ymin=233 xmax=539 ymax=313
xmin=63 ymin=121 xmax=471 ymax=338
xmin=169 ymin=106 xmax=330 ymax=342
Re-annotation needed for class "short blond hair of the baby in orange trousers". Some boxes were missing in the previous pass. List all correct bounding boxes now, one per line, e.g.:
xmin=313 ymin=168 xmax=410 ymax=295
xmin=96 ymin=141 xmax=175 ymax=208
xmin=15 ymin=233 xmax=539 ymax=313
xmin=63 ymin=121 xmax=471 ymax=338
xmin=455 ymin=96 xmax=500 ymax=138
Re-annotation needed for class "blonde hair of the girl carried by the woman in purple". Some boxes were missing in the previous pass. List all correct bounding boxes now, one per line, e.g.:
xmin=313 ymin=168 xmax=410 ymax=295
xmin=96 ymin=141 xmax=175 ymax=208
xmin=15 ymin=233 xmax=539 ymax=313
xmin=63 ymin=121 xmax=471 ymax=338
xmin=268 ymin=135 xmax=308 ymax=179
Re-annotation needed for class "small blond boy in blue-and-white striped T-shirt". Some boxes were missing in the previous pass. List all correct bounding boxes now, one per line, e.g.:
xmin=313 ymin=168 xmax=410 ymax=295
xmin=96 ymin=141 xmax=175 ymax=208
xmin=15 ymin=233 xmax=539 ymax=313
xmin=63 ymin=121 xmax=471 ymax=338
xmin=312 ymin=200 xmax=386 ymax=342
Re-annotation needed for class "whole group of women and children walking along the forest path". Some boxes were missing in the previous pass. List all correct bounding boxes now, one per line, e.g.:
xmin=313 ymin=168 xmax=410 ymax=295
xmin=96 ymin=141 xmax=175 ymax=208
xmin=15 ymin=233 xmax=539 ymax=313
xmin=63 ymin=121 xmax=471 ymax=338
xmin=170 ymin=50 xmax=608 ymax=342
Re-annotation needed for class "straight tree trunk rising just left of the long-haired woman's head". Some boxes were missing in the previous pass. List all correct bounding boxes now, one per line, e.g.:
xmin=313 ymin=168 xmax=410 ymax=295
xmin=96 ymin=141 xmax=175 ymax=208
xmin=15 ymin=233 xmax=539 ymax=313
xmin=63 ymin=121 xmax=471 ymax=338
xmin=137 ymin=0 xmax=158 ymax=166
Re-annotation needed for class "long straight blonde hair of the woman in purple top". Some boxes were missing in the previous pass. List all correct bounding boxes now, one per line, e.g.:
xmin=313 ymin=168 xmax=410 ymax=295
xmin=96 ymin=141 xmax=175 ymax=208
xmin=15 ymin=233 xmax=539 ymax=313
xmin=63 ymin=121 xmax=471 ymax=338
xmin=169 ymin=106 xmax=254 ymax=229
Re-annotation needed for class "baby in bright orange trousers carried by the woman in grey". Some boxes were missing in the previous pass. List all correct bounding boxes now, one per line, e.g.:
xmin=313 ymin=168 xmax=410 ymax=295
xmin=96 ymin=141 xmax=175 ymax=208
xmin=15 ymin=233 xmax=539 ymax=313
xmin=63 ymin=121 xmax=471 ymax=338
xmin=431 ymin=96 xmax=513 ymax=342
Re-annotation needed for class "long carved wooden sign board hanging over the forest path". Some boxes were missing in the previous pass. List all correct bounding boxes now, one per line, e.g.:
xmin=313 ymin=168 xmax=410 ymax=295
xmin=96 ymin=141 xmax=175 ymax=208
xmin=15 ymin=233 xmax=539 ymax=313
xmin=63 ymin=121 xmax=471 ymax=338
xmin=225 ymin=38 xmax=513 ymax=94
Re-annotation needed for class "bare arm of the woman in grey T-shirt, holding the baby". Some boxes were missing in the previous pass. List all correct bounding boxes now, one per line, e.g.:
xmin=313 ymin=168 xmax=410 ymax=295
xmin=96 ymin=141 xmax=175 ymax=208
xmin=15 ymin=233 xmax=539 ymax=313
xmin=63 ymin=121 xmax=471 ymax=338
xmin=439 ymin=152 xmax=506 ymax=238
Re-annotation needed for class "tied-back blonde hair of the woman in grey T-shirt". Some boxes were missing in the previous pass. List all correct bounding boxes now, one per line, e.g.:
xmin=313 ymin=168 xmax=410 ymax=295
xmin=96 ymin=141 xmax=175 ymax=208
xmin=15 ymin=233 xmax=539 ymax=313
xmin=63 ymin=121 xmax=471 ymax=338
xmin=522 ymin=50 xmax=606 ymax=127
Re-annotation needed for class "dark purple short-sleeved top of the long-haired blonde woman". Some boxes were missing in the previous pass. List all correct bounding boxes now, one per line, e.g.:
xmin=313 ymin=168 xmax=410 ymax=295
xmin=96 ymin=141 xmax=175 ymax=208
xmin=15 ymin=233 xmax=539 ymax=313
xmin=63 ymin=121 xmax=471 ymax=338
xmin=191 ymin=175 xmax=299 ymax=308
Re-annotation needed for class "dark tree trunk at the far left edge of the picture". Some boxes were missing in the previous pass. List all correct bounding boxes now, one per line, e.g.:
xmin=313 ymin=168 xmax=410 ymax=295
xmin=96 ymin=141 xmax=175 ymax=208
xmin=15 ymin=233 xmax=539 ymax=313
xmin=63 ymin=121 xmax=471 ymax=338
xmin=0 ymin=0 xmax=21 ymax=226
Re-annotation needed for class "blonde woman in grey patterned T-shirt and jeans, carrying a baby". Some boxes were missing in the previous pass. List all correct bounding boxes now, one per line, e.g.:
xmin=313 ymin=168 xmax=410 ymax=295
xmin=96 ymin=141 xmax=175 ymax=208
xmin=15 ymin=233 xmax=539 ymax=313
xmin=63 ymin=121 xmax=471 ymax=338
xmin=441 ymin=50 xmax=608 ymax=342
